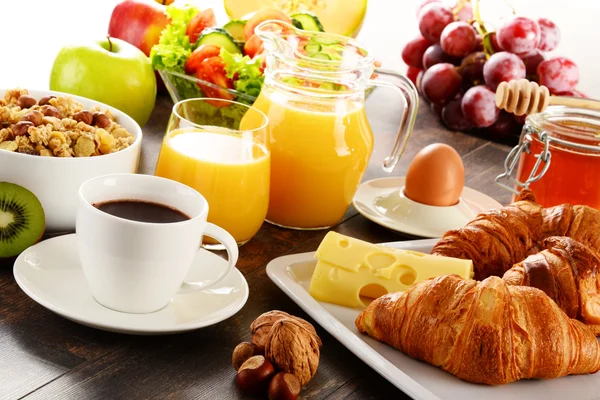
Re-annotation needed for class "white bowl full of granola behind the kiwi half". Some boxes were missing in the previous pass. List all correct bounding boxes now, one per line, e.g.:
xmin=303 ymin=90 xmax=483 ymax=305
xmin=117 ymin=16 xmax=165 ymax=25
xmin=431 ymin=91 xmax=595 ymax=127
xmin=0 ymin=89 xmax=142 ymax=232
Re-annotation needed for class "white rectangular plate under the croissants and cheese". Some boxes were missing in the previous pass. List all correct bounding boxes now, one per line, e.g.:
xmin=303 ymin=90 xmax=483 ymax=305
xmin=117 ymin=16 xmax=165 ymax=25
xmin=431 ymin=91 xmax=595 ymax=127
xmin=267 ymin=239 xmax=600 ymax=400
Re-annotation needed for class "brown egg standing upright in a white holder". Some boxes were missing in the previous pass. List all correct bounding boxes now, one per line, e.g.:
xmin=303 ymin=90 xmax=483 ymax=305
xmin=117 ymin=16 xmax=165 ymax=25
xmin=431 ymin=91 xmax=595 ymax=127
xmin=404 ymin=143 xmax=465 ymax=206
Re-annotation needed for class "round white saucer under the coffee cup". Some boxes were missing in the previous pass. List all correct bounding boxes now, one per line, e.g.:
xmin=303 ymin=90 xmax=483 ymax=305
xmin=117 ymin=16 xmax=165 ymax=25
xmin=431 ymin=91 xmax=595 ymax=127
xmin=13 ymin=234 xmax=248 ymax=335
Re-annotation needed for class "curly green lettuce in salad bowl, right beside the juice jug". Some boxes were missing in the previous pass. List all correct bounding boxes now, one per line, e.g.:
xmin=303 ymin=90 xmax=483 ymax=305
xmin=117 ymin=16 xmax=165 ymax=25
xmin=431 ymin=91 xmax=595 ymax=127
xmin=220 ymin=49 xmax=265 ymax=98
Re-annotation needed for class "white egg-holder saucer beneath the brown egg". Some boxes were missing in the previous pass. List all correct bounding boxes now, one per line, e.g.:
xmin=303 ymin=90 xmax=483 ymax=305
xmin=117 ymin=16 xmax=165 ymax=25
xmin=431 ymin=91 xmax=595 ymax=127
xmin=352 ymin=177 xmax=502 ymax=238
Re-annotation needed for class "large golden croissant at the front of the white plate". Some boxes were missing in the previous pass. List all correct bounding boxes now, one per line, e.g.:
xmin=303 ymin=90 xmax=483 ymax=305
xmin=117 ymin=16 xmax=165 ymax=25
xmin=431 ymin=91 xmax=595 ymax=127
xmin=356 ymin=275 xmax=600 ymax=385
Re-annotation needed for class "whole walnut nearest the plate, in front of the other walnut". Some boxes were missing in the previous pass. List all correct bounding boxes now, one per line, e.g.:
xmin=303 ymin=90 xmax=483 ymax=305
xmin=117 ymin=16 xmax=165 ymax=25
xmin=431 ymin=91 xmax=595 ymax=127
xmin=265 ymin=318 xmax=320 ymax=386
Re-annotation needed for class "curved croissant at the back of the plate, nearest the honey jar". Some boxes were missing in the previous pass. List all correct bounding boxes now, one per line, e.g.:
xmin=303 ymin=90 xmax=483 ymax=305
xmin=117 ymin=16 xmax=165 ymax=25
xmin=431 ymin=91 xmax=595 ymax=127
xmin=431 ymin=190 xmax=600 ymax=280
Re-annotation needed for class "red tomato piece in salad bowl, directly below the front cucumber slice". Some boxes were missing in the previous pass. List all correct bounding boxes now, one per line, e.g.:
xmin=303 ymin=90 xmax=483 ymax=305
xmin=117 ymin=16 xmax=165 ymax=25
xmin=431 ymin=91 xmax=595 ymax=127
xmin=196 ymin=56 xmax=235 ymax=107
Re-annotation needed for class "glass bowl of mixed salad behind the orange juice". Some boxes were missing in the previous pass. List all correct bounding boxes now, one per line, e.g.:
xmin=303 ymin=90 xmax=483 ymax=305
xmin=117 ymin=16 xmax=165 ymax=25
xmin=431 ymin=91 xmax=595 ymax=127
xmin=150 ymin=4 xmax=380 ymax=116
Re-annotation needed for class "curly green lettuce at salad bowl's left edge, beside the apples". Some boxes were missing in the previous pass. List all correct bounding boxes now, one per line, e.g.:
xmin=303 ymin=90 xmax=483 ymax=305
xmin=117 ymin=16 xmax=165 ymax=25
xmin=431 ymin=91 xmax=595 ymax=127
xmin=150 ymin=4 xmax=200 ymax=73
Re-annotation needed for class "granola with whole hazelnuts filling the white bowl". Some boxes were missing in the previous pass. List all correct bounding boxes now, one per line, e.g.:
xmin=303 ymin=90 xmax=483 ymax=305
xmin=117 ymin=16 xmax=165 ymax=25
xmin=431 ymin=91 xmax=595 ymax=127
xmin=0 ymin=89 xmax=134 ymax=157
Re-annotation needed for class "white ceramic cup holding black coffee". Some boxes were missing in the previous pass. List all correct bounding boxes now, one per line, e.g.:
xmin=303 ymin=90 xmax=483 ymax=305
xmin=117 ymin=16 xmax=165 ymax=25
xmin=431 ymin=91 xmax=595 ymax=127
xmin=76 ymin=174 xmax=238 ymax=313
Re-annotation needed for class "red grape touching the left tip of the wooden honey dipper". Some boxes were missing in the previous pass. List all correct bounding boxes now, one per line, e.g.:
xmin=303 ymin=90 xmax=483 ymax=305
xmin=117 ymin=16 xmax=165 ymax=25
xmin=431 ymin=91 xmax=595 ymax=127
xmin=462 ymin=85 xmax=500 ymax=128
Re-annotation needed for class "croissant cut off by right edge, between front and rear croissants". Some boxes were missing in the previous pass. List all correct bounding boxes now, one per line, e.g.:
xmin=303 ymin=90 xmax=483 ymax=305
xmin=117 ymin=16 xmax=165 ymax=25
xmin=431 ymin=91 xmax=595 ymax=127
xmin=502 ymin=237 xmax=600 ymax=335
